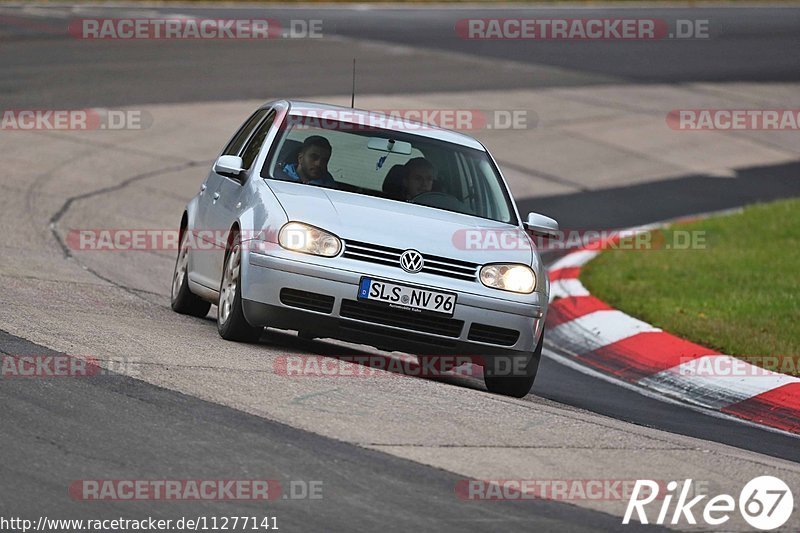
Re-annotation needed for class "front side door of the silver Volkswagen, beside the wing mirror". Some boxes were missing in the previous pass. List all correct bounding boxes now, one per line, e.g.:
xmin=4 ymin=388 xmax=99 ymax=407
xmin=208 ymin=109 xmax=275 ymax=289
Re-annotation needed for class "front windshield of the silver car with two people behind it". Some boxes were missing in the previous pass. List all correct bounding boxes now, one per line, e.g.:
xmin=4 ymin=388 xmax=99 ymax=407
xmin=261 ymin=116 xmax=516 ymax=224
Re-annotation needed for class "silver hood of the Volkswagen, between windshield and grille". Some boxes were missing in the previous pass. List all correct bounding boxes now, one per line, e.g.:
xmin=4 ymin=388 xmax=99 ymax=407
xmin=268 ymin=180 xmax=538 ymax=266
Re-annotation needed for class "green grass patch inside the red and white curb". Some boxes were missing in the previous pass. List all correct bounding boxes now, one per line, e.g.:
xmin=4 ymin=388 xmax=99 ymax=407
xmin=581 ymin=199 xmax=800 ymax=373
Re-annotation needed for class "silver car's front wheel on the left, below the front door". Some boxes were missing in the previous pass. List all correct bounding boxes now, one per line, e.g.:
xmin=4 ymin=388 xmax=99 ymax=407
xmin=217 ymin=234 xmax=264 ymax=342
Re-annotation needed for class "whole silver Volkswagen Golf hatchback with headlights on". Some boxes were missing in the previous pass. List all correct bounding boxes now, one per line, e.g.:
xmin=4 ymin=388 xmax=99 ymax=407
xmin=172 ymin=101 xmax=558 ymax=397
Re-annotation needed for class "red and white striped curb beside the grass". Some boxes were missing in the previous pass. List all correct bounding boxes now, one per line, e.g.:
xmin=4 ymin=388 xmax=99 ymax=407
xmin=547 ymin=228 xmax=800 ymax=435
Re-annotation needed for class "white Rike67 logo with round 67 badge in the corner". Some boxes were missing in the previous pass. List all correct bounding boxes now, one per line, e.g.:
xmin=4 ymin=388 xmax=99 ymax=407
xmin=622 ymin=476 xmax=794 ymax=531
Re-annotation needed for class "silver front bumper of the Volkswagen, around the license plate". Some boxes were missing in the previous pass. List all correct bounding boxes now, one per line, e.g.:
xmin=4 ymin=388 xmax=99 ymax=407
xmin=241 ymin=250 xmax=547 ymax=355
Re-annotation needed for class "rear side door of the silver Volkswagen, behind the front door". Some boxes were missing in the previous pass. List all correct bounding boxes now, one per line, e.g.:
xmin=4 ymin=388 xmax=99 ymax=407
xmin=189 ymin=109 xmax=270 ymax=290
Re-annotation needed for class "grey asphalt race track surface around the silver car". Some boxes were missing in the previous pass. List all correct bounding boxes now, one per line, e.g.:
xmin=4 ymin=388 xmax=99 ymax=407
xmin=0 ymin=4 xmax=800 ymax=531
